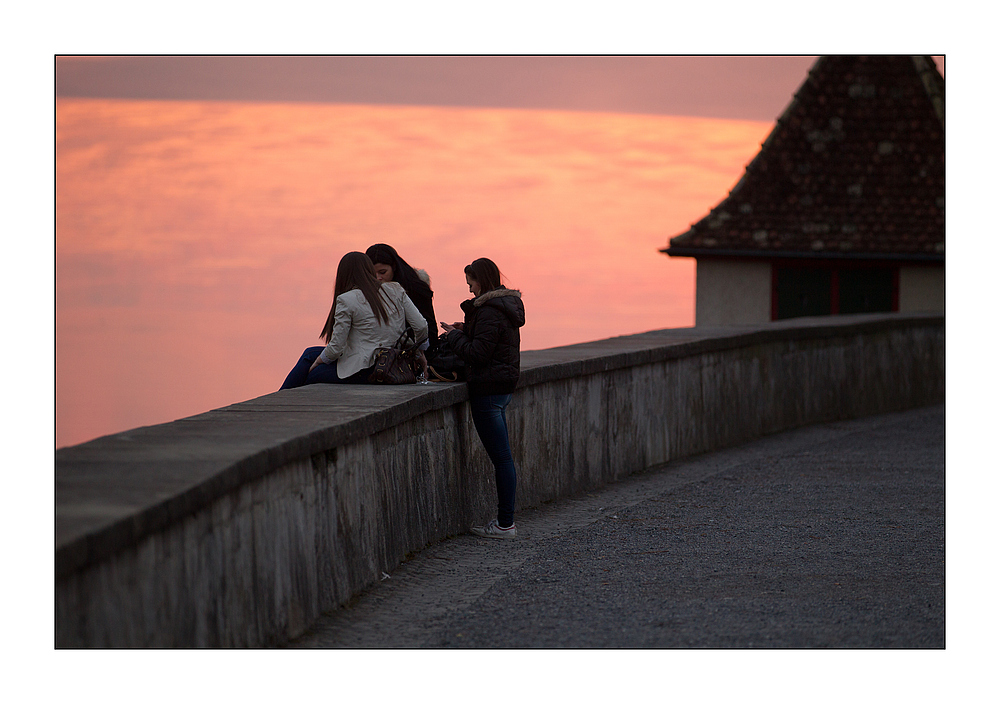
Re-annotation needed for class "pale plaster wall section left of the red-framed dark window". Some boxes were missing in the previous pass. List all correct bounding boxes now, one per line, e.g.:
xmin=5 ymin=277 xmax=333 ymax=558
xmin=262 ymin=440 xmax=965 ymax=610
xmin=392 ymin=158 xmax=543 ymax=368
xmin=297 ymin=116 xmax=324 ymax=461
xmin=694 ymin=259 xmax=771 ymax=325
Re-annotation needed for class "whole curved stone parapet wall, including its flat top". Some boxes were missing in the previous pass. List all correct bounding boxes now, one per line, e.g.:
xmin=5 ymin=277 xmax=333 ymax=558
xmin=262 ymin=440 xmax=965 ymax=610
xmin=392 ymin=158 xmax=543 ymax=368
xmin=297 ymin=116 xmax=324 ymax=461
xmin=56 ymin=314 xmax=944 ymax=647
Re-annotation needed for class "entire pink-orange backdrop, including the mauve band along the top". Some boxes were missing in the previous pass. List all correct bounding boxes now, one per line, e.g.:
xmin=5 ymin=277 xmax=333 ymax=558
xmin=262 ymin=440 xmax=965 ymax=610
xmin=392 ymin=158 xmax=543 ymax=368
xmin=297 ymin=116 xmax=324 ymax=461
xmin=55 ymin=56 xmax=944 ymax=446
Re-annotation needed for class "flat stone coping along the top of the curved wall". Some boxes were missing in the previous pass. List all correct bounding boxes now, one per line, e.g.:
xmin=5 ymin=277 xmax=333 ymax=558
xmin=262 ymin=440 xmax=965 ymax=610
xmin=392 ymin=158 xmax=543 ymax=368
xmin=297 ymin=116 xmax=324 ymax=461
xmin=55 ymin=313 xmax=944 ymax=580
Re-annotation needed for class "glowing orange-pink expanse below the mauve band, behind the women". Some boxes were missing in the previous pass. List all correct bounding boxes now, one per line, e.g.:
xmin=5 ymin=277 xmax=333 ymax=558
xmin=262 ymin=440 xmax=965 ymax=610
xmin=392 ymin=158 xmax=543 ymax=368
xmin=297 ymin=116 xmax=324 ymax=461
xmin=56 ymin=99 xmax=771 ymax=447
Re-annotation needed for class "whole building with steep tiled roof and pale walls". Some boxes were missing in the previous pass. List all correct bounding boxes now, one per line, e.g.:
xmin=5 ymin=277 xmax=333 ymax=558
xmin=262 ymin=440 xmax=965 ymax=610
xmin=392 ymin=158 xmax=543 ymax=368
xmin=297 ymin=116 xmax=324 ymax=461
xmin=661 ymin=56 xmax=944 ymax=325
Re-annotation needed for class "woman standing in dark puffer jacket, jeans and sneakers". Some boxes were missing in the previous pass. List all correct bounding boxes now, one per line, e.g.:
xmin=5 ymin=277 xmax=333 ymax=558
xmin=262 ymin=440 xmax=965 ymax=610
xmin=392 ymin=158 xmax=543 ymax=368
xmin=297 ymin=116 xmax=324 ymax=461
xmin=441 ymin=258 xmax=524 ymax=538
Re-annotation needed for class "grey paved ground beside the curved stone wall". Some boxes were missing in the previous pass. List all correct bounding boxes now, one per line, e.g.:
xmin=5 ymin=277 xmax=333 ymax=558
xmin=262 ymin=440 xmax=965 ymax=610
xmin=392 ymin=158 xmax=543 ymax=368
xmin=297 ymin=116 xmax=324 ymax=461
xmin=291 ymin=406 xmax=945 ymax=648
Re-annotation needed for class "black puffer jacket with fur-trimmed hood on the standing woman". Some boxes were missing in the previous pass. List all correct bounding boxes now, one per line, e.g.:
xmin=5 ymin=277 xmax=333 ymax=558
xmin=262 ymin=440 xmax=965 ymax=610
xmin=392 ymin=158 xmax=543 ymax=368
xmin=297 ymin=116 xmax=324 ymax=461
xmin=448 ymin=288 xmax=524 ymax=396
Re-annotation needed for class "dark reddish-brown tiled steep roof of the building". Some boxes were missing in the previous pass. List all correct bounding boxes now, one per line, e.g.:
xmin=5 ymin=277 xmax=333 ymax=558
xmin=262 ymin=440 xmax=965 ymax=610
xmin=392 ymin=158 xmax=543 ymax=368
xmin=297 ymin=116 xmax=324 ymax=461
xmin=661 ymin=56 xmax=944 ymax=261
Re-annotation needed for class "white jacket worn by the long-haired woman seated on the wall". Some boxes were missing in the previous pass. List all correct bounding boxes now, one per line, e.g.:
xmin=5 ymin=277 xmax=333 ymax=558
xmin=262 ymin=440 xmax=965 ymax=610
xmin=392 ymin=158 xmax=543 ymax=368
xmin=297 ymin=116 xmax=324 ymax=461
xmin=319 ymin=281 xmax=427 ymax=379
